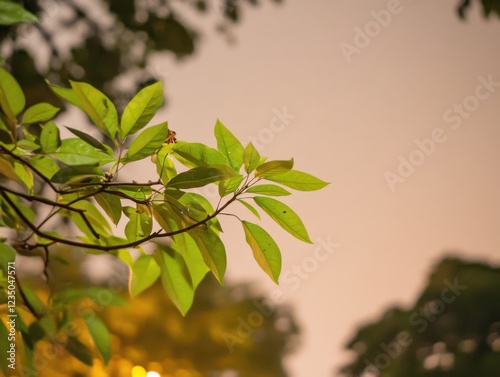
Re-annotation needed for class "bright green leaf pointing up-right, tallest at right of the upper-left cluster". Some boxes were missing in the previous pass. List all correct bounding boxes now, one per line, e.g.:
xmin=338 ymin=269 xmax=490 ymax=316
xmin=121 ymin=82 xmax=163 ymax=139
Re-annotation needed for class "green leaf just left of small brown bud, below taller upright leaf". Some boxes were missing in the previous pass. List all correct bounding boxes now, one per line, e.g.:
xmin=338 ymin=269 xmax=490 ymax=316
xmin=125 ymin=122 xmax=168 ymax=162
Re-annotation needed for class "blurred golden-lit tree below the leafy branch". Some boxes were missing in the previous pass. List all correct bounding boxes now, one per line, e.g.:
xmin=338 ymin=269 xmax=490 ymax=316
xmin=24 ymin=249 xmax=299 ymax=377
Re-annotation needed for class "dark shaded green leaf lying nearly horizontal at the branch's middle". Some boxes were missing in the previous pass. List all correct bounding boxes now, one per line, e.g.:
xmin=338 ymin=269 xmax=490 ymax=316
xmin=167 ymin=165 xmax=236 ymax=189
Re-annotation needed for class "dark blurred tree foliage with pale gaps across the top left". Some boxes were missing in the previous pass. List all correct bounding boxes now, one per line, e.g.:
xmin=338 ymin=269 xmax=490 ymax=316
xmin=0 ymin=0 xmax=282 ymax=106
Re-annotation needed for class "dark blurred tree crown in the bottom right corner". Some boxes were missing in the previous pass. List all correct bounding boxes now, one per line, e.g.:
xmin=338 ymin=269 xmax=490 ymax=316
xmin=341 ymin=258 xmax=500 ymax=377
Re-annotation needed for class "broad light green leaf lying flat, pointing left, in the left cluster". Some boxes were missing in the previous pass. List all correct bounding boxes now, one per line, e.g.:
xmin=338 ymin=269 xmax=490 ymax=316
xmin=53 ymin=138 xmax=115 ymax=166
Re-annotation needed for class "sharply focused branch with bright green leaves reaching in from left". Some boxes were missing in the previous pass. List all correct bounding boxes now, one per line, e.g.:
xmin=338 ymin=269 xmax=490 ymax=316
xmin=0 ymin=68 xmax=327 ymax=365
